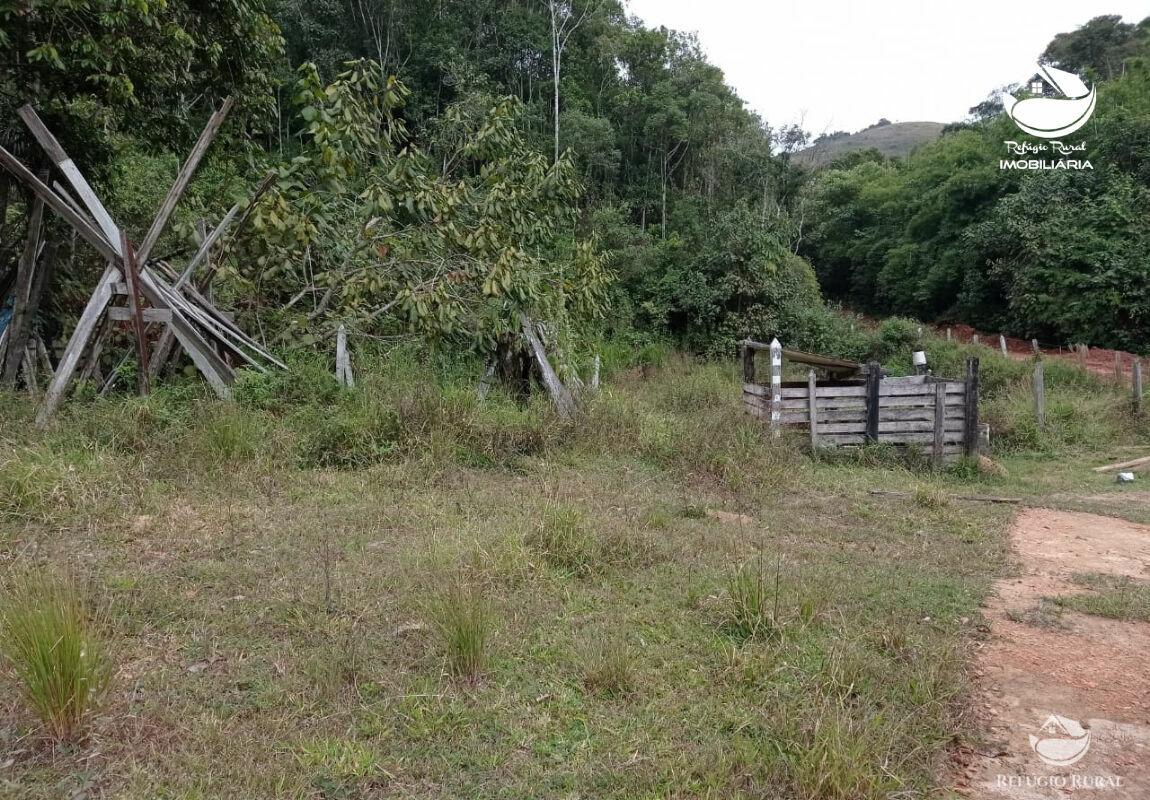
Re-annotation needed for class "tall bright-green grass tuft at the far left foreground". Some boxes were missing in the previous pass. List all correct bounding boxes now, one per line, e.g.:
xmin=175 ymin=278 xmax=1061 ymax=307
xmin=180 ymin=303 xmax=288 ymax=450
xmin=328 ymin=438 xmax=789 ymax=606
xmin=0 ymin=575 xmax=110 ymax=741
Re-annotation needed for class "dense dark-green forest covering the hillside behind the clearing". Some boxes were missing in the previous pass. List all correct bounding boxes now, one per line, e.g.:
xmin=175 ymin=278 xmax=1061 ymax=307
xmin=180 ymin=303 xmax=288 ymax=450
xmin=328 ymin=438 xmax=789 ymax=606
xmin=0 ymin=0 xmax=1150 ymax=383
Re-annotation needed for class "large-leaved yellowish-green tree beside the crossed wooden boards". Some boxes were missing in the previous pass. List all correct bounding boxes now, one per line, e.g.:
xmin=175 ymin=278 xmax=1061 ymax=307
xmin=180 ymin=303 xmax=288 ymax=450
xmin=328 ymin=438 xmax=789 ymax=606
xmin=228 ymin=62 xmax=611 ymax=349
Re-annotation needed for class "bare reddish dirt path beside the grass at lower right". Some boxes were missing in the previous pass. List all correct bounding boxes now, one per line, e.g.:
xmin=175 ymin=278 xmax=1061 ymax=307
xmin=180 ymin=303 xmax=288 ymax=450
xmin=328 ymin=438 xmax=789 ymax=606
xmin=956 ymin=509 xmax=1150 ymax=800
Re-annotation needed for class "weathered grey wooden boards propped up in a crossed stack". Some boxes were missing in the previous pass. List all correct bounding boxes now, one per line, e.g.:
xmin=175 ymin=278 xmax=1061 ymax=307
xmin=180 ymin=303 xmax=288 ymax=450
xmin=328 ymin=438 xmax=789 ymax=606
xmin=0 ymin=98 xmax=286 ymax=426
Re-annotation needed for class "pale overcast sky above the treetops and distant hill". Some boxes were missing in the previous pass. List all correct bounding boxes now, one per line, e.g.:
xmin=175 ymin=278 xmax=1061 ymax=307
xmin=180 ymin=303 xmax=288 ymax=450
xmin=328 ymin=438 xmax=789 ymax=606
xmin=628 ymin=0 xmax=1150 ymax=136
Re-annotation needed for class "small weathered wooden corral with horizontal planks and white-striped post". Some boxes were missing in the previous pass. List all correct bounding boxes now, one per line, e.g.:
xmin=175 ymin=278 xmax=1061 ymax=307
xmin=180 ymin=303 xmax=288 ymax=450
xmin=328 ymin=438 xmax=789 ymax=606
xmin=739 ymin=339 xmax=979 ymax=463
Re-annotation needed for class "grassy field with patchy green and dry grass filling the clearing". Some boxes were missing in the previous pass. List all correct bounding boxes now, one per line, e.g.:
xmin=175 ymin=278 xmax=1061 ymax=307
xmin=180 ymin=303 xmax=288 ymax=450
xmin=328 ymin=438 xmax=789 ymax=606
xmin=0 ymin=344 xmax=1134 ymax=800
